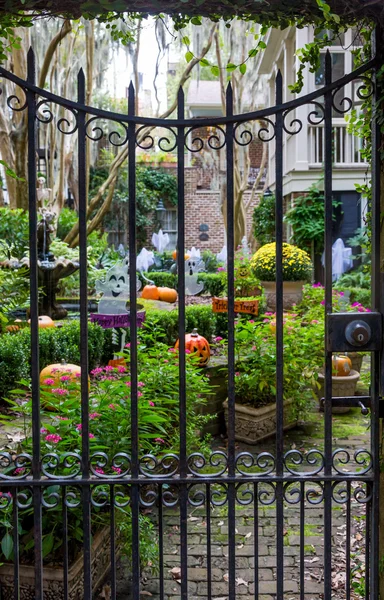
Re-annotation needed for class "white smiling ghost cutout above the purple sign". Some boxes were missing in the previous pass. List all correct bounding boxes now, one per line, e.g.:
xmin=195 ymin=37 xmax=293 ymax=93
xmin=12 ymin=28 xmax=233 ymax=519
xmin=96 ymin=258 xmax=141 ymax=315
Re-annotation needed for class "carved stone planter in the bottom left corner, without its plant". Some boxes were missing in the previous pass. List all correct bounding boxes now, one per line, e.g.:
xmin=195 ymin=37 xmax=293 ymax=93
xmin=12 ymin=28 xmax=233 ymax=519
xmin=0 ymin=527 xmax=118 ymax=600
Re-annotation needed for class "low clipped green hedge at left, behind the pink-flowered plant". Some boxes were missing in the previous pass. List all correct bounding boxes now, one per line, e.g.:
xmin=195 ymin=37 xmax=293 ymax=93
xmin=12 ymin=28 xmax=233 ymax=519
xmin=0 ymin=321 xmax=113 ymax=398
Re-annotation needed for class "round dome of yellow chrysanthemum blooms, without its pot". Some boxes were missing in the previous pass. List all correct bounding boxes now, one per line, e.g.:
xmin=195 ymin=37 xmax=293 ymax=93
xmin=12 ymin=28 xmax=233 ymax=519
xmin=251 ymin=243 xmax=312 ymax=281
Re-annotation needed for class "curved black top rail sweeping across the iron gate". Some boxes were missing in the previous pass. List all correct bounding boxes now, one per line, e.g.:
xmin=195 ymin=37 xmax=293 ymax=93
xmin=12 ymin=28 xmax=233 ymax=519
xmin=0 ymin=56 xmax=381 ymax=128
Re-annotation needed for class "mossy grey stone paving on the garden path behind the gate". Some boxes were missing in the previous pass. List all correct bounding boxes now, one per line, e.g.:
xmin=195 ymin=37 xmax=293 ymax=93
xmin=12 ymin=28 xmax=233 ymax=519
xmin=117 ymin=409 xmax=369 ymax=600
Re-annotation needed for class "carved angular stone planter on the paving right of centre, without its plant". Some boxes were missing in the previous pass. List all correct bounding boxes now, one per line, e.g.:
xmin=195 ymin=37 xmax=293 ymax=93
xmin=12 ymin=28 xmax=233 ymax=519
xmin=223 ymin=400 xmax=297 ymax=444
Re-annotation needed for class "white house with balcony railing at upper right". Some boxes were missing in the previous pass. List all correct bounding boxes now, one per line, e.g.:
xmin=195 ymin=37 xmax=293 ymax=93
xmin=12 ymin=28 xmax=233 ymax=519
xmin=255 ymin=27 xmax=369 ymax=239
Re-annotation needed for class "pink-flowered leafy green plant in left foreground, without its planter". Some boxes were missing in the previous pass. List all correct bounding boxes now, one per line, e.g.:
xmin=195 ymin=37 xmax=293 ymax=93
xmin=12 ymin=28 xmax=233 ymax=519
xmin=0 ymin=344 xmax=210 ymax=566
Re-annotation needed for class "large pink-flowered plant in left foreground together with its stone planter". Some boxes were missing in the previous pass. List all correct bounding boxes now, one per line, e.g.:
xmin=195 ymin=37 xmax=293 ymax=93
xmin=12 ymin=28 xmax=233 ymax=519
xmin=0 ymin=344 xmax=210 ymax=600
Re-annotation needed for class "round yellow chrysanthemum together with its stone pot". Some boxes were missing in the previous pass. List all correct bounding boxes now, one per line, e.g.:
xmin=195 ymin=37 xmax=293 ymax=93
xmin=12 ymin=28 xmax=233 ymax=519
xmin=251 ymin=243 xmax=312 ymax=310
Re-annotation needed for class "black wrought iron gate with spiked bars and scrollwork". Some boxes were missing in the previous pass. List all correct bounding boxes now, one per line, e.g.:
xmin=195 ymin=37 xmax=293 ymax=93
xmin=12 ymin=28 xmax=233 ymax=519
xmin=0 ymin=39 xmax=381 ymax=600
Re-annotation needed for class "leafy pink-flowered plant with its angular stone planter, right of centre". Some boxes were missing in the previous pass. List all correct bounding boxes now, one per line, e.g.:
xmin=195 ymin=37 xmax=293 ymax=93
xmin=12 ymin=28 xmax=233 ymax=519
xmin=219 ymin=318 xmax=307 ymax=444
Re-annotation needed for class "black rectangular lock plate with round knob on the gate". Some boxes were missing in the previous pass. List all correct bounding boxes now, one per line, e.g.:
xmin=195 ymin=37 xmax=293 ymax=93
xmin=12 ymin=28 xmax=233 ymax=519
xmin=327 ymin=312 xmax=382 ymax=352
